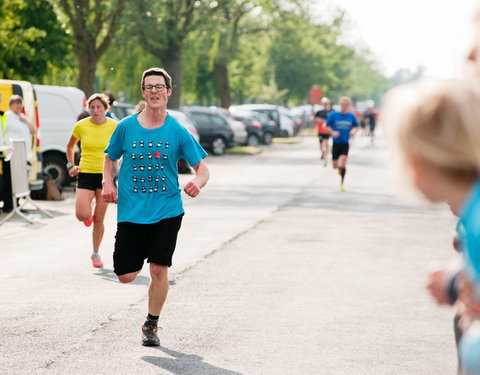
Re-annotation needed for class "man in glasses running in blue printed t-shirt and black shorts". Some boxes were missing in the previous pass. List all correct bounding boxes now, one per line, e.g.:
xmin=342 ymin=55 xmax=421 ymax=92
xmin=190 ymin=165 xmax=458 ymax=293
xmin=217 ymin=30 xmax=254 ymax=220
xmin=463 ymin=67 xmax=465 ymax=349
xmin=102 ymin=68 xmax=209 ymax=346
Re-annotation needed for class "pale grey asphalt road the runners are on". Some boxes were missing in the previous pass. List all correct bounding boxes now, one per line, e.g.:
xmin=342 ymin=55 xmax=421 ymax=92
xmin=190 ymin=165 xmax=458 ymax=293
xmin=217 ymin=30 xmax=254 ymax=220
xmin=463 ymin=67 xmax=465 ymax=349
xmin=0 ymin=132 xmax=456 ymax=375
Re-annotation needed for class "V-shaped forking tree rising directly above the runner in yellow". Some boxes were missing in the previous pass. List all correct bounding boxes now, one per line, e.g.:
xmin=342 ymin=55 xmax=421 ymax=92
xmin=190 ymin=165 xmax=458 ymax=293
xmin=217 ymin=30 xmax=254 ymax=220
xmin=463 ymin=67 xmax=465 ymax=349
xmin=53 ymin=0 xmax=127 ymax=96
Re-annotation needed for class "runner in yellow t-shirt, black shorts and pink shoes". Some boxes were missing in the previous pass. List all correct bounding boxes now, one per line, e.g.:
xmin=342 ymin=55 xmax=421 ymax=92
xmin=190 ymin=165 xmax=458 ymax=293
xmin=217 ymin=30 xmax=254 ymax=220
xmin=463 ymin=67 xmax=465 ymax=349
xmin=67 ymin=94 xmax=116 ymax=268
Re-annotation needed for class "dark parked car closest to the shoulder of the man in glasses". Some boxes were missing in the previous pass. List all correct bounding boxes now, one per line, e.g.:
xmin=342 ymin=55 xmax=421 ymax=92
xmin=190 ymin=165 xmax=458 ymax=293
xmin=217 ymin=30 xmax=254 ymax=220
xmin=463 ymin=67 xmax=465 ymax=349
xmin=180 ymin=106 xmax=234 ymax=155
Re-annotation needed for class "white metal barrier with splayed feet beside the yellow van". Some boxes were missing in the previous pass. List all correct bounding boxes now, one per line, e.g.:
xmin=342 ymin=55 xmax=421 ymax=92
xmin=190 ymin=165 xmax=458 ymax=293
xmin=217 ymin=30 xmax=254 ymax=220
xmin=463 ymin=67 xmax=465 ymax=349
xmin=0 ymin=139 xmax=53 ymax=225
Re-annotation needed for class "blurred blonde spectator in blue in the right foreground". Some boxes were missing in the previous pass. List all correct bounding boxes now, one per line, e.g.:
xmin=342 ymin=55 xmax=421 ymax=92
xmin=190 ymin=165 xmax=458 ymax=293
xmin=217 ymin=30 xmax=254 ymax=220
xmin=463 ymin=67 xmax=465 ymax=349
xmin=383 ymin=79 xmax=480 ymax=374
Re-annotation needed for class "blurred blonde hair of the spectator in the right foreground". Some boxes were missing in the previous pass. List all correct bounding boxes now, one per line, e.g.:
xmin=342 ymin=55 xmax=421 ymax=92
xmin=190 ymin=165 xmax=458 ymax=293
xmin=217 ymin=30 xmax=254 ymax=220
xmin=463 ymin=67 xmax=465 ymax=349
xmin=382 ymin=79 xmax=480 ymax=178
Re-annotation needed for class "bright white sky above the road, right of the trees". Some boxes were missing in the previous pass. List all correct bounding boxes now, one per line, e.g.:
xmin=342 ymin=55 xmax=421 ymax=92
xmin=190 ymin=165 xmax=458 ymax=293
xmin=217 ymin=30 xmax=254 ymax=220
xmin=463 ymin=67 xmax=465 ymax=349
xmin=316 ymin=0 xmax=480 ymax=78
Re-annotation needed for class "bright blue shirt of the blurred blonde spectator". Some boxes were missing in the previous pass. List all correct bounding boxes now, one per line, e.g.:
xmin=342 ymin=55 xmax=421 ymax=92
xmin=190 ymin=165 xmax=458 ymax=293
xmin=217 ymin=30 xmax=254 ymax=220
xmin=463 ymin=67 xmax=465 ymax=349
xmin=460 ymin=179 xmax=480 ymax=286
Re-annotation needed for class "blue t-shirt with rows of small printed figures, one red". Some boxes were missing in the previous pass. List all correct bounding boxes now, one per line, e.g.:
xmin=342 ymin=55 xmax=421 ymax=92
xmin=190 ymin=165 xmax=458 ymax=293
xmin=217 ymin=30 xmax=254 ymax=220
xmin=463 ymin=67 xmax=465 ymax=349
xmin=105 ymin=113 xmax=207 ymax=224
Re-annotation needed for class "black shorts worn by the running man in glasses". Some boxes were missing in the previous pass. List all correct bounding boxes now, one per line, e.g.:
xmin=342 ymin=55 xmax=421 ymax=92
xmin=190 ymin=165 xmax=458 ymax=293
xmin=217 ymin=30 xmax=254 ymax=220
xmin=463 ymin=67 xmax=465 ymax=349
xmin=113 ymin=214 xmax=183 ymax=276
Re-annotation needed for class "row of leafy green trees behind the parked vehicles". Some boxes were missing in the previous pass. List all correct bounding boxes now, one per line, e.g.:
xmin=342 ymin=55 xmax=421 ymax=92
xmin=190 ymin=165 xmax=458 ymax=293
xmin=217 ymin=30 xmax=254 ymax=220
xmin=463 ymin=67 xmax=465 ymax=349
xmin=0 ymin=0 xmax=394 ymax=107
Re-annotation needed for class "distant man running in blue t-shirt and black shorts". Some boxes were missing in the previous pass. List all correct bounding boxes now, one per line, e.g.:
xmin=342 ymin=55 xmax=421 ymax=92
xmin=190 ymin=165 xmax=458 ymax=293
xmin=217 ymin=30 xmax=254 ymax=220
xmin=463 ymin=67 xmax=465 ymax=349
xmin=327 ymin=96 xmax=358 ymax=191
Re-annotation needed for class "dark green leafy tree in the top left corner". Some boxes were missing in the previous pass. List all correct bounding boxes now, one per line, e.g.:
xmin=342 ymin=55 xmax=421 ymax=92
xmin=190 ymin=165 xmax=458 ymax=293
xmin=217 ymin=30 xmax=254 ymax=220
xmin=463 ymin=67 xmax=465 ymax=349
xmin=0 ymin=0 xmax=69 ymax=81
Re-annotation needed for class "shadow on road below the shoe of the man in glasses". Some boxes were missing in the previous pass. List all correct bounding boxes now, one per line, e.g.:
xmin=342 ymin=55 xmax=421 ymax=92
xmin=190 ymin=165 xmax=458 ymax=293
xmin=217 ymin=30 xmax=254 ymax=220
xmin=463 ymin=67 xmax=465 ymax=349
xmin=142 ymin=347 xmax=242 ymax=375
